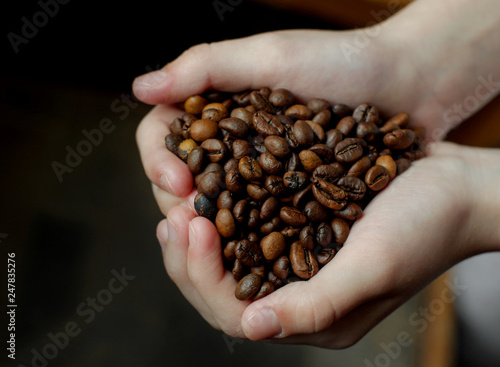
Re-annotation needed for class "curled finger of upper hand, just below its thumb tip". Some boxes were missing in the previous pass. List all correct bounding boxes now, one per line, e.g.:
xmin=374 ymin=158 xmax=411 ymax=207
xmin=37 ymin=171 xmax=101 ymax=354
xmin=136 ymin=106 xmax=193 ymax=197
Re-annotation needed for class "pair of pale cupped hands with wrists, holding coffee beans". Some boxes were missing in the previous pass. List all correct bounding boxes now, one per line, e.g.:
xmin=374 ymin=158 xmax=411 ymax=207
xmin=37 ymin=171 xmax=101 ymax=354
xmin=134 ymin=0 xmax=500 ymax=348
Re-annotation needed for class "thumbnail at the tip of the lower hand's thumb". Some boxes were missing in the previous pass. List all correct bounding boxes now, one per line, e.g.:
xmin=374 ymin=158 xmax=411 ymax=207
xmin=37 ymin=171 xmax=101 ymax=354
xmin=243 ymin=306 xmax=283 ymax=340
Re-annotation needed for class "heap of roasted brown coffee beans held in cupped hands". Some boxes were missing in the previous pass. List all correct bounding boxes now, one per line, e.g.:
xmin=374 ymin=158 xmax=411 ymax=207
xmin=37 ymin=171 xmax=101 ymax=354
xmin=165 ymin=88 xmax=425 ymax=300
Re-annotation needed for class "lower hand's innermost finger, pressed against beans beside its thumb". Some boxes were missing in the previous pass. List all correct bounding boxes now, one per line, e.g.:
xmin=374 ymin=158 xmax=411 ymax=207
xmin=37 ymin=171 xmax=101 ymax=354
xmin=187 ymin=217 xmax=249 ymax=337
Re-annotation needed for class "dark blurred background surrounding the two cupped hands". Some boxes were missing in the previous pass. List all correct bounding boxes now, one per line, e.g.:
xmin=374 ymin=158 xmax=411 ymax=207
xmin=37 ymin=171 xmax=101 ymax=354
xmin=0 ymin=0 xmax=500 ymax=367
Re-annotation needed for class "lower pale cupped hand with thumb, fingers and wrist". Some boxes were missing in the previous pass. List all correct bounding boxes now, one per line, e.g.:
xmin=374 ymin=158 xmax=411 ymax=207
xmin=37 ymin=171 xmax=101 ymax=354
xmin=157 ymin=143 xmax=500 ymax=348
